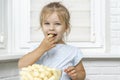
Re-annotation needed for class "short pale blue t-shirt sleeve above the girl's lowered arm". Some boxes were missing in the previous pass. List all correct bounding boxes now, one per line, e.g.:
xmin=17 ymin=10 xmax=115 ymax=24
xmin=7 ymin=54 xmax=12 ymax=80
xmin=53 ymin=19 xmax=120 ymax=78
xmin=74 ymin=49 xmax=83 ymax=66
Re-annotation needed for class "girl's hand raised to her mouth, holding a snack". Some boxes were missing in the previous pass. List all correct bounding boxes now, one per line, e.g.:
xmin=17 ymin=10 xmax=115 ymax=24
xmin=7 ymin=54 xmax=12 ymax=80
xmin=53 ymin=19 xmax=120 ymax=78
xmin=40 ymin=36 xmax=56 ymax=52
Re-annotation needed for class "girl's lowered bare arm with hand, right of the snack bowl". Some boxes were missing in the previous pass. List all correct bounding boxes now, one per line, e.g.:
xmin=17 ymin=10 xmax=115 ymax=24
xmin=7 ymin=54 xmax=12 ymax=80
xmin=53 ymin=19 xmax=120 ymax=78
xmin=65 ymin=61 xmax=86 ymax=80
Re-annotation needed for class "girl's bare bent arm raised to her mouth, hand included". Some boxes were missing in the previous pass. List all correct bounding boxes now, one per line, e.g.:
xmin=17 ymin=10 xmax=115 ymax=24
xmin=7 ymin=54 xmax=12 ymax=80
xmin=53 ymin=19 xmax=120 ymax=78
xmin=18 ymin=37 xmax=55 ymax=68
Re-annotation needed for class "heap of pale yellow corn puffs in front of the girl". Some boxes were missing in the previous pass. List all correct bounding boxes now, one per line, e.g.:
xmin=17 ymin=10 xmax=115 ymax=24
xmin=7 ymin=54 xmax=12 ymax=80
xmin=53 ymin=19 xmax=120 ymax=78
xmin=20 ymin=64 xmax=61 ymax=80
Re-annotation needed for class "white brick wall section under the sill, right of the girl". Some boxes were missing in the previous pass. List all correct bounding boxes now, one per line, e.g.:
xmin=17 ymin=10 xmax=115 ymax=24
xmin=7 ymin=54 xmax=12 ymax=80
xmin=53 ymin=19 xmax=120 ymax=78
xmin=84 ymin=59 xmax=120 ymax=80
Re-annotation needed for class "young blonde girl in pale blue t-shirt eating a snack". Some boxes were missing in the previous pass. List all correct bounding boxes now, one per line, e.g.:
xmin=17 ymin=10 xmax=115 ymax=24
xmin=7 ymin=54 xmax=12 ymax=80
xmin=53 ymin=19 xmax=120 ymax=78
xmin=18 ymin=2 xmax=85 ymax=80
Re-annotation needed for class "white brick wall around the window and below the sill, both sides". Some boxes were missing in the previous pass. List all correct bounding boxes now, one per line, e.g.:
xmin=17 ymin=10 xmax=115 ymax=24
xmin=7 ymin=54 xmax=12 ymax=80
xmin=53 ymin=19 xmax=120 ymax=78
xmin=0 ymin=0 xmax=120 ymax=80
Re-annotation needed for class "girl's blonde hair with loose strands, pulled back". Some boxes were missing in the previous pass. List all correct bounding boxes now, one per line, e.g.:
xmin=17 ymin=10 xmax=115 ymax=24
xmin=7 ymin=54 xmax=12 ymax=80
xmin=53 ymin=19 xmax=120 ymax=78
xmin=40 ymin=2 xmax=70 ymax=35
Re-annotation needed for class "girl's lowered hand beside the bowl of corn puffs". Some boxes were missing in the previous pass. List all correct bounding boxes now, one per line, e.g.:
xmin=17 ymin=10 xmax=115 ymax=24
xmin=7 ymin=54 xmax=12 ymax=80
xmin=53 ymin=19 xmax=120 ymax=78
xmin=64 ymin=66 xmax=77 ymax=80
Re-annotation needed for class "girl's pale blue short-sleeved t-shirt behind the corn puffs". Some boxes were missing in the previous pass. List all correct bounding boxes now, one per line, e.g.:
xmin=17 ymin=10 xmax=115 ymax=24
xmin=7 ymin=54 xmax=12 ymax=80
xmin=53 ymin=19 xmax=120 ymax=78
xmin=36 ymin=44 xmax=83 ymax=80
